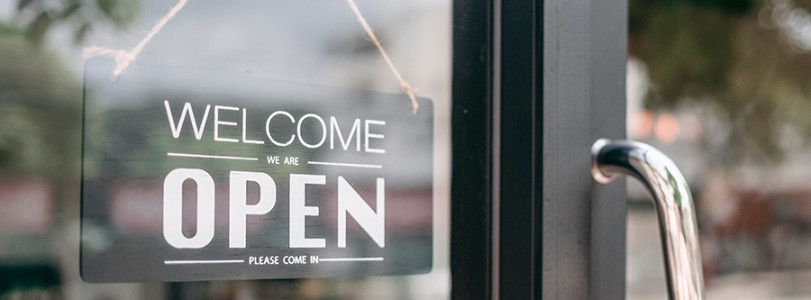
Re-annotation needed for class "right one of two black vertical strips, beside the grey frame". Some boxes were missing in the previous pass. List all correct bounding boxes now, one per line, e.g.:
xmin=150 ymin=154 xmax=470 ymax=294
xmin=494 ymin=0 xmax=543 ymax=299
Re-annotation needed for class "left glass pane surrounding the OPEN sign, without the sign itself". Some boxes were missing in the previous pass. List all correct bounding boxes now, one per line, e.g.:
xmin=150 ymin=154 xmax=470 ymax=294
xmin=0 ymin=0 xmax=451 ymax=299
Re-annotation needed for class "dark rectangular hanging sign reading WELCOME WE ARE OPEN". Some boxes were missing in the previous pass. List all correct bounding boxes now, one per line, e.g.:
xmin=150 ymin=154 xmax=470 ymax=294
xmin=81 ymin=60 xmax=433 ymax=282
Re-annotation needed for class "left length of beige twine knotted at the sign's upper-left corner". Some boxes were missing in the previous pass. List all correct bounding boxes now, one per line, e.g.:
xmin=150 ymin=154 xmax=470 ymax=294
xmin=82 ymin=0 xmax=189 ymax=78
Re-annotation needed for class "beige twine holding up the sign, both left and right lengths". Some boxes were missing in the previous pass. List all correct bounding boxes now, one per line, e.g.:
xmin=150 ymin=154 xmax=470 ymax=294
xmin=83 ymin=0 xmax=420 ymax=114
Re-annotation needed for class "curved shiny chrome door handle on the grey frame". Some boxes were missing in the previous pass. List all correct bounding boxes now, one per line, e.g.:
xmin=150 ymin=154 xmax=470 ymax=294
xmin=591 ymin=139 xmax=704 ymax=299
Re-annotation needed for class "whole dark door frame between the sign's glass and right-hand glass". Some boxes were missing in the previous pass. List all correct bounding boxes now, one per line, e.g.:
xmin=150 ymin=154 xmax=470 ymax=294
xmin=451 ymin=0 xmax=627 ymax=299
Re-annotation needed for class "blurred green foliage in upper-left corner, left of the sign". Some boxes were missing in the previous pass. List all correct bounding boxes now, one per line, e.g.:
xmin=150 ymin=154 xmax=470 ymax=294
xmin=0 ymin=0 xmax=140 ymax=173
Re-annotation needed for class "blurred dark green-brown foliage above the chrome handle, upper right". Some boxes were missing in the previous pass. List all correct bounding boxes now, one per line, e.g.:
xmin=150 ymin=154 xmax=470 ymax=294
xmin=629 ymin=0 xmax=811 ymax=166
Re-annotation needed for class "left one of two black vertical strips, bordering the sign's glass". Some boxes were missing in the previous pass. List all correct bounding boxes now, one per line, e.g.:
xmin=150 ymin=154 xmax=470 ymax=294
xmin=451 ymin=0 xmax=493 ymax=299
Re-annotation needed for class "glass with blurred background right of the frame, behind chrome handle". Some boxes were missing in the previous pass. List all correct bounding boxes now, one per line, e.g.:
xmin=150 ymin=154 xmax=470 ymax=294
xmin=628 ymin=0 xmax=811 ymax=299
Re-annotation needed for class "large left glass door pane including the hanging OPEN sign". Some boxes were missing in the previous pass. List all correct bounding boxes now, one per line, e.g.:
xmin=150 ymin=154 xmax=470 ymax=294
xmin=0 ymin=0 xmax=452 ymax=299
